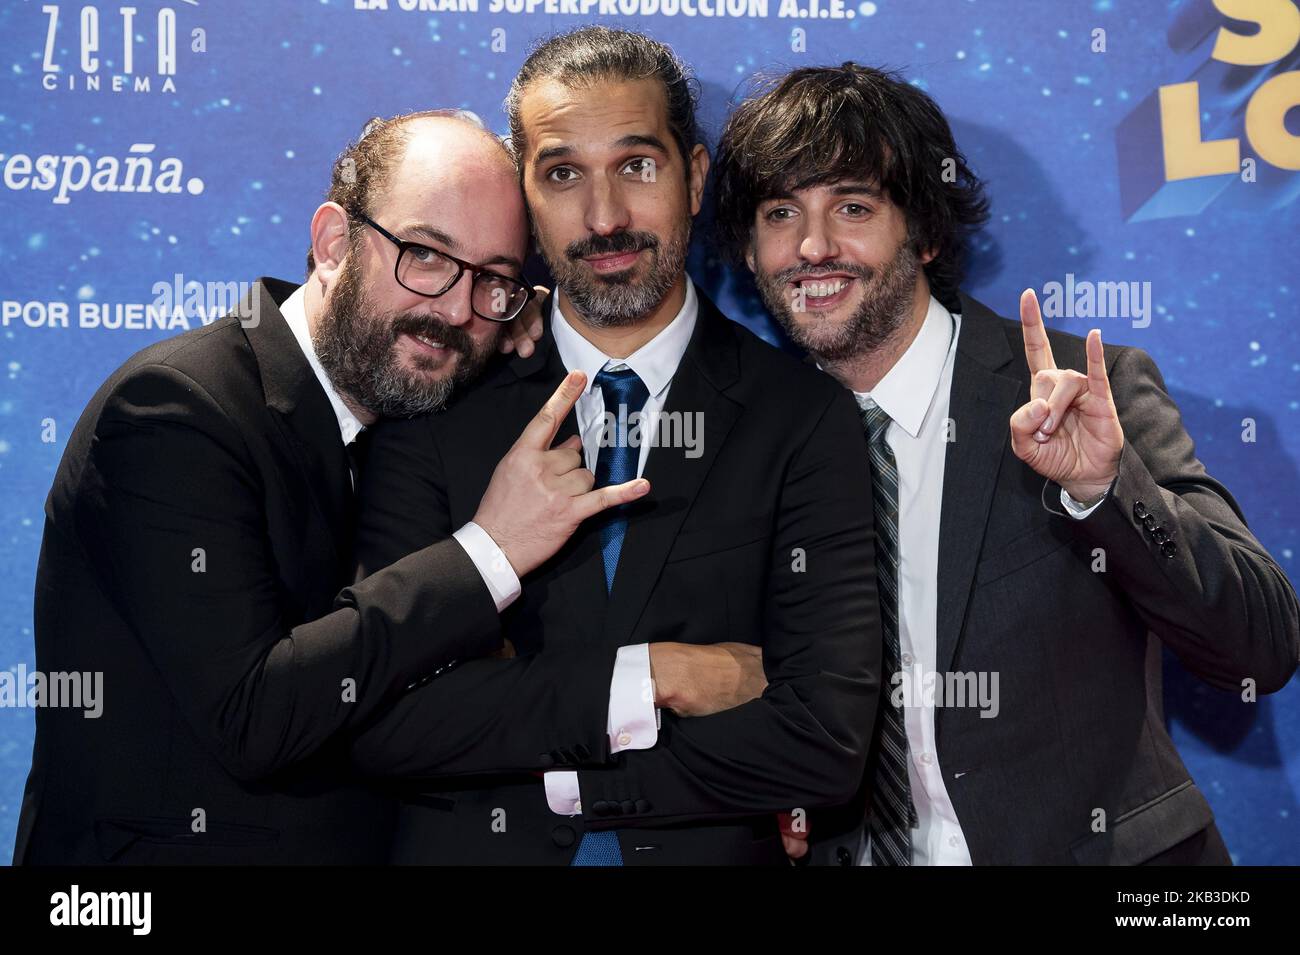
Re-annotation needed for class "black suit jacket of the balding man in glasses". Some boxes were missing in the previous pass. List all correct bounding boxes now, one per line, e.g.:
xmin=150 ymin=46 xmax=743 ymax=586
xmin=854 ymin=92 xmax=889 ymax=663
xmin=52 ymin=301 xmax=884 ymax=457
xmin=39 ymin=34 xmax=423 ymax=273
xmin=14 ymin=279 xmax=501 ymax=864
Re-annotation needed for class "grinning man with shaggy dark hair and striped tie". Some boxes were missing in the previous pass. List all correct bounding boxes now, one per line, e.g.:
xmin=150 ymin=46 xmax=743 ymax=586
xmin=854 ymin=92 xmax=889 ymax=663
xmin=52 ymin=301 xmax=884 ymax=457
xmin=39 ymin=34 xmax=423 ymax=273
xmin=718 ymin=62 xmax=1300 ymax=865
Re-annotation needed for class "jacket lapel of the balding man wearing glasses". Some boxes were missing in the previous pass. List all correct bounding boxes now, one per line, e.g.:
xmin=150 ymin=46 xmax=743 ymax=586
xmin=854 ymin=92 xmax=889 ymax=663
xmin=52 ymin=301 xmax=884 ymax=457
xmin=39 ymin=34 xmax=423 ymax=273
xmin=241 ymin=278 xmax=354 ymax=570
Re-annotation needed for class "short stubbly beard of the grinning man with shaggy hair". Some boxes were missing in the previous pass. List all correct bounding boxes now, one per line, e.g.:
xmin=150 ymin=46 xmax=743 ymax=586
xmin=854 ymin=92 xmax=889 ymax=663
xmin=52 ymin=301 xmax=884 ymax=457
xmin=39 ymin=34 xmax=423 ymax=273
xmin=757 ymin=239 xmax=920 ymax=364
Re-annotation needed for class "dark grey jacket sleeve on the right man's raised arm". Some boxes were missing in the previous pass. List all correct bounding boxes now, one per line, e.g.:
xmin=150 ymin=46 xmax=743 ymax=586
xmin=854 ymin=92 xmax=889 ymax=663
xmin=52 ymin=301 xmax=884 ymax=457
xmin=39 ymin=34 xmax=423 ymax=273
xmin=1053 ymin=348 xmax=1300 ymax=693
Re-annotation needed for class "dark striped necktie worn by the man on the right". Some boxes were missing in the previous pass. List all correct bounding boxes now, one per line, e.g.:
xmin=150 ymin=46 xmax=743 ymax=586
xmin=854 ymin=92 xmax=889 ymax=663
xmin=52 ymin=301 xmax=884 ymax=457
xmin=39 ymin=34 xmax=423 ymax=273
xmin=861 ymin=403 xmax=917 ymax=865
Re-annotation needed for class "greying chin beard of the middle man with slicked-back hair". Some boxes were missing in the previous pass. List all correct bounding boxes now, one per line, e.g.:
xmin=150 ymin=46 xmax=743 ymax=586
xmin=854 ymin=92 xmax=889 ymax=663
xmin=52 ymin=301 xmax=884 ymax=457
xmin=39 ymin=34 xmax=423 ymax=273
xmin=538 ymin=220 xmax=690 ymax=329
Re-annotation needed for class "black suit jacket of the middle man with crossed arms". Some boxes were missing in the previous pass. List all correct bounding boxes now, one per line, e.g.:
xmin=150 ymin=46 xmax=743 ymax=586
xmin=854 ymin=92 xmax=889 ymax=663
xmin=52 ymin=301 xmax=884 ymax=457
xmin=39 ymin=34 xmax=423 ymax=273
xmin=356 ymin=289 xmax=880 ymax=864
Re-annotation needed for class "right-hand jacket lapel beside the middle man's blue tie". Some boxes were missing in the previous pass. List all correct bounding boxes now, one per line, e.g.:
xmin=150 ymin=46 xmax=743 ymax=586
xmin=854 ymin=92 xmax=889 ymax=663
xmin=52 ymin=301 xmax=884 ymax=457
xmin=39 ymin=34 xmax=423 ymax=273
xmin=592 ymin=287 xmax=742 ymax=646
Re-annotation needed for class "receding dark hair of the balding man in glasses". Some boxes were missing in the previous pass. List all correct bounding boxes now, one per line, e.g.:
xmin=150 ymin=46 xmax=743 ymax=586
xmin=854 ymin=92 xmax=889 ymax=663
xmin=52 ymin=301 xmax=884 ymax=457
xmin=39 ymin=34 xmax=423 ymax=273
xmin=307 ymin=109 xmax=508 ymax=275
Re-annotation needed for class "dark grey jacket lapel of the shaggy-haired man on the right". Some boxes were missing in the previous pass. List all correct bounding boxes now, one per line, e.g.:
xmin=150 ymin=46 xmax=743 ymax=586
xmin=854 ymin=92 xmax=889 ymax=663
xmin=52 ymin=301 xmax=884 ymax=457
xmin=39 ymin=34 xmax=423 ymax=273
xmin=936 ymin=295 xmax=1021 ymax=673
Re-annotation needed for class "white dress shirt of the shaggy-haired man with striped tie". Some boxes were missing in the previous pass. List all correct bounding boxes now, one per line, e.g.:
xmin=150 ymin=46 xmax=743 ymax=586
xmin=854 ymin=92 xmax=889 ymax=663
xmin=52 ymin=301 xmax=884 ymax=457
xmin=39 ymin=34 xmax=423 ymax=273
xmin=853 ymin=296 xmax=1100 ymax=865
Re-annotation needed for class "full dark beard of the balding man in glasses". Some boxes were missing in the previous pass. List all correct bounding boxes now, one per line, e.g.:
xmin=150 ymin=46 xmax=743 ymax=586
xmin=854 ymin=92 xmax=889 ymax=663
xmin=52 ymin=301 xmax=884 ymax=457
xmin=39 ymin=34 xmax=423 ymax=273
xmin=312 ymin=257 xmax=491 ymax=418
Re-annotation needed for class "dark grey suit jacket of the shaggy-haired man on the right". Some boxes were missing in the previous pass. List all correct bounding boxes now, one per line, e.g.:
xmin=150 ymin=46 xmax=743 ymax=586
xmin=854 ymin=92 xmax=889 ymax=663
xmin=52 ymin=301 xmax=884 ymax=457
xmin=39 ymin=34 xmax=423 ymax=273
xmin=810 ymin=295 xmax=1300 ymax=865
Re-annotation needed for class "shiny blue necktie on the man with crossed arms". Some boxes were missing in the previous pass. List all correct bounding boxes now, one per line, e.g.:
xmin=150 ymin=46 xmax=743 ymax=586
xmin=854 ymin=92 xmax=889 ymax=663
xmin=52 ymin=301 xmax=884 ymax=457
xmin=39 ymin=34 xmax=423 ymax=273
xmin=571 ymin=368 xmax=650 ymax=865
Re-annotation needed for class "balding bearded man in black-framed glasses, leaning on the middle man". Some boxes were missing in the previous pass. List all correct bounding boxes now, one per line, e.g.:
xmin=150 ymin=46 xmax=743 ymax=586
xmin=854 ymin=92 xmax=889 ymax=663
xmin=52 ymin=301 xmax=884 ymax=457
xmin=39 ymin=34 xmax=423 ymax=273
xmin=14 ymin=112 xmax=645 ymax=864
